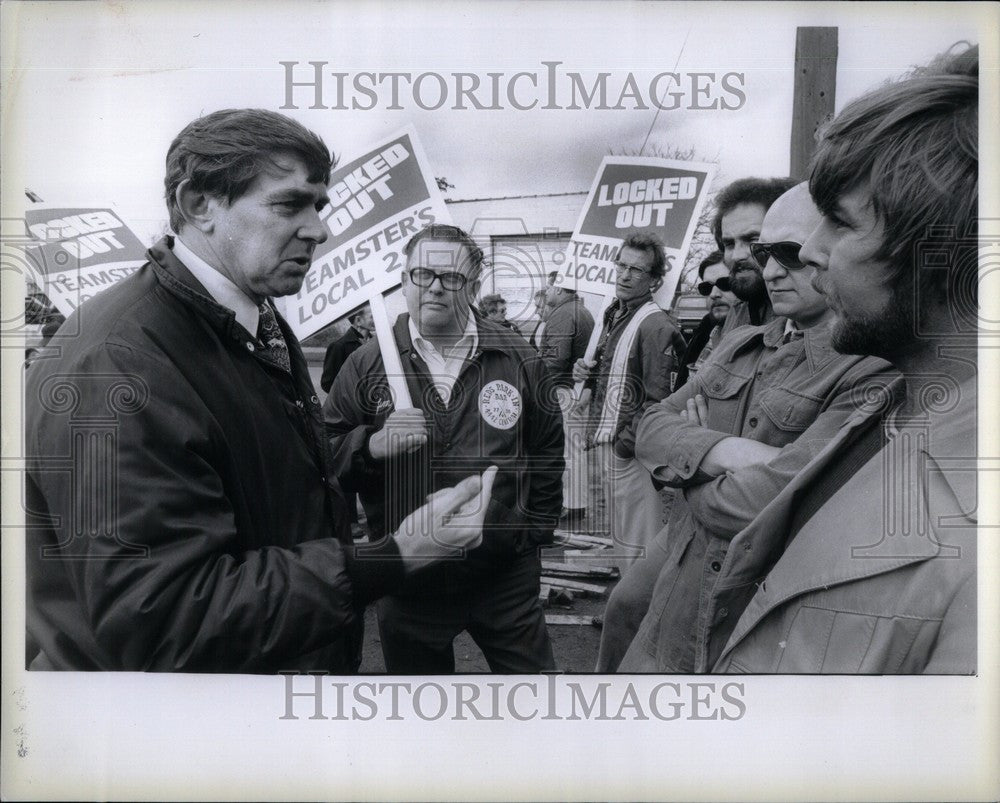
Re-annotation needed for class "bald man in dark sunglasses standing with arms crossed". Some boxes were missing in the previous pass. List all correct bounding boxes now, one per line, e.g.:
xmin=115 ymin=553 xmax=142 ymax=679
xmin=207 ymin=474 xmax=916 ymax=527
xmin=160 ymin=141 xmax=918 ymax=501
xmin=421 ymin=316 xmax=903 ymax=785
xmin=599 ymin=184 xmax=889 ymax=672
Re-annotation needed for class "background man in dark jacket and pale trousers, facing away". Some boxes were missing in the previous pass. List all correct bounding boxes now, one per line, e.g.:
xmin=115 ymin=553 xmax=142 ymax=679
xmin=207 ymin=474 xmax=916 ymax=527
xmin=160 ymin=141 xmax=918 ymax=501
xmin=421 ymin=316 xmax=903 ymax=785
xmin=539 ymin=285 xmax=594 ymax=529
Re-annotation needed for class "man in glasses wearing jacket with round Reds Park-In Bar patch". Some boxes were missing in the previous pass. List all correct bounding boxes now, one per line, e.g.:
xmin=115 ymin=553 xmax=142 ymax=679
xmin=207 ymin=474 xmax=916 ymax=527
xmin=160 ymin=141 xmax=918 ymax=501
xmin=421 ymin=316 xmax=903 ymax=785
xmin=323 ymin=225 xmax=563 ymax=674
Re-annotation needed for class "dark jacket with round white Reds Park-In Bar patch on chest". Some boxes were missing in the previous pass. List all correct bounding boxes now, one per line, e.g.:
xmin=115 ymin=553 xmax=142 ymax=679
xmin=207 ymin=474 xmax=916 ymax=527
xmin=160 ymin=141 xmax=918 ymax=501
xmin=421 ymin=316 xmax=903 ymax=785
xmin=323 ymin=314 xmax=563 ymax=583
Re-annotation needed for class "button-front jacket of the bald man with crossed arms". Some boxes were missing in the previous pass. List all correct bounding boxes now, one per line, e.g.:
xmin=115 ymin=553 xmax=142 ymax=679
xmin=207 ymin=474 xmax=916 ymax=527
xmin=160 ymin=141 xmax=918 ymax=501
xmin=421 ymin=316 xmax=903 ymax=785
xmin=621 ymin=318 xmax=897 ymax=672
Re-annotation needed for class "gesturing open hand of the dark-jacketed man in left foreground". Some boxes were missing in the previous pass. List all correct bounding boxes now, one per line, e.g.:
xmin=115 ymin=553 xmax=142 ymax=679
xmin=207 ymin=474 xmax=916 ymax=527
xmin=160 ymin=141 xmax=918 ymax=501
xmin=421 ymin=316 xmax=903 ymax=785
xmin=394 ymin=466 xmax=497 ymax=572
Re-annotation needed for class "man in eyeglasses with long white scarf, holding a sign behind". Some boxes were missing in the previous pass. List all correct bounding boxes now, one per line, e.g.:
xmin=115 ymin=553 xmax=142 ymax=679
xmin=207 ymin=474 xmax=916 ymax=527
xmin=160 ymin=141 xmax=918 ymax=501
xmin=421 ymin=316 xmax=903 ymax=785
xmin=573 ymin=233 xmax=687 ymax=563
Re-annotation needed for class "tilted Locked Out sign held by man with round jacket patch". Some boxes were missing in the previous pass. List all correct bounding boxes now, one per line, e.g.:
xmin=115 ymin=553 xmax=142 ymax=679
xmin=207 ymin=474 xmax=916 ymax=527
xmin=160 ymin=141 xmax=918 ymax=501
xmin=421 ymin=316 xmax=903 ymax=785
xmin=283 ymin=126 xmax=451 ymax=342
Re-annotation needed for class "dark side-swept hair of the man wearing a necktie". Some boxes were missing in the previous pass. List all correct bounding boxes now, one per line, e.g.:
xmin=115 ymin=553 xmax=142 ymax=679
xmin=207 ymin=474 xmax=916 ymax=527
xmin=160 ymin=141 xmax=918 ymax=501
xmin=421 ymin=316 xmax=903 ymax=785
xmin=164 ymin=109 xmax=334 ymax=232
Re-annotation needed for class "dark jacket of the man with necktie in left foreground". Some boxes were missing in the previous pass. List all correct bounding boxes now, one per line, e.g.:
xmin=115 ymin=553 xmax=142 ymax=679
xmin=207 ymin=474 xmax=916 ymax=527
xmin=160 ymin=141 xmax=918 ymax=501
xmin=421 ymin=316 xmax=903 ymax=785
xmin=26 ymin=237 xmax=402 ymax=672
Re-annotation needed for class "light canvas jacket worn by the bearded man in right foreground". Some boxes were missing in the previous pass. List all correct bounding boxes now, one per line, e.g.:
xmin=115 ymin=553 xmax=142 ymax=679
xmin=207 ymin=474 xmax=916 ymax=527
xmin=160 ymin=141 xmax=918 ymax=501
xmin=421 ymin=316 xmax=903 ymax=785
xmin=712 ymin=380 xmax=978 ymax=674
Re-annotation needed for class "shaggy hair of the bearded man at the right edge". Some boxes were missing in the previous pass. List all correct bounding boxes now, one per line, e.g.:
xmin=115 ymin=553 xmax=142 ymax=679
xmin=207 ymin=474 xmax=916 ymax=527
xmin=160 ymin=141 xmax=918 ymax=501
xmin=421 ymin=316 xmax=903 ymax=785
xmin=809 ymin=47 xmax=979 ymax=293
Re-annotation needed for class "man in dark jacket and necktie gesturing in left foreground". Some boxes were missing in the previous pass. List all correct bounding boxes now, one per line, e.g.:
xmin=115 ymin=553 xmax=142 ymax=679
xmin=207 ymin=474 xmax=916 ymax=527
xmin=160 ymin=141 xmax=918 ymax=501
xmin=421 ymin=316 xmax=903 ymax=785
xmin=26 ymin=110 xmax=489 ymax=673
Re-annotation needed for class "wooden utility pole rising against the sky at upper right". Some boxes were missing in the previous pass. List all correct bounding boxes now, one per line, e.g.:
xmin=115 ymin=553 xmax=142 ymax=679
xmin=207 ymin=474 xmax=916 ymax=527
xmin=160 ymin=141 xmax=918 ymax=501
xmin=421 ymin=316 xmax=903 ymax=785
xmin=789 ymin=28 xmax=837 ymax=179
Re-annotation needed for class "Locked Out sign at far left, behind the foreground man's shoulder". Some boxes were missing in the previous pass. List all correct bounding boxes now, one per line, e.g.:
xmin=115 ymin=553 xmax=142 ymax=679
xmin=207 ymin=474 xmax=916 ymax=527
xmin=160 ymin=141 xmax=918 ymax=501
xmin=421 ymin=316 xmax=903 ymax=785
xmin=24 ymin=206 xmax=146 ymax=315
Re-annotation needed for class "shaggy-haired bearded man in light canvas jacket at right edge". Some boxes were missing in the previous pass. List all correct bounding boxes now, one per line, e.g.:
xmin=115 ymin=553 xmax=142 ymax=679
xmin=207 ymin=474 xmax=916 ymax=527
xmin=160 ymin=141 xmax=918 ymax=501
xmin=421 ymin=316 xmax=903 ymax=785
xmin=712 ymin=42 xmax=982 ymax=674
